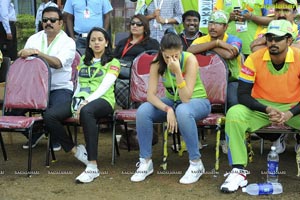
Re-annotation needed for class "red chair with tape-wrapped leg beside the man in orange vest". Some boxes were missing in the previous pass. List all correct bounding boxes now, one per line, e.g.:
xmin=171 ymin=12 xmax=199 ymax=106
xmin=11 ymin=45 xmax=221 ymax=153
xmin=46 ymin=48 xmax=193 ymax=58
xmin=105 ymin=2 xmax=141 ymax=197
xmin=196 ymin=52 xmax=228 ymax=171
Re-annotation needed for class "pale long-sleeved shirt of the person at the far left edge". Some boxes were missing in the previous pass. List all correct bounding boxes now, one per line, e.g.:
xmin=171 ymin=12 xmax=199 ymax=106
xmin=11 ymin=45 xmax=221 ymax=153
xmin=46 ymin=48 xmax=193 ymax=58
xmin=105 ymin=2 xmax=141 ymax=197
xmin=0 ymin=0 xmax=17 ymax=34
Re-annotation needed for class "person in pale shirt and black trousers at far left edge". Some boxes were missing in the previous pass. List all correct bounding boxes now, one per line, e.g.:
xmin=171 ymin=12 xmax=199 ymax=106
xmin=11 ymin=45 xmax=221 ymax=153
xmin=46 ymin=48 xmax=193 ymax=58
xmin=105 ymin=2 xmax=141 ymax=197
xmin=0 ymin=0 xmax=17 ymax=60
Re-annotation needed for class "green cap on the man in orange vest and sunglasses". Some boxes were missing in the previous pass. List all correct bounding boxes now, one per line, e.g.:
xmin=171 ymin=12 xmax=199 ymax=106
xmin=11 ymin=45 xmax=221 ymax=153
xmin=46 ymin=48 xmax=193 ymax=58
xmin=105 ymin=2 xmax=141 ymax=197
xmin=266 ymin=19 xmax=293 ymax=36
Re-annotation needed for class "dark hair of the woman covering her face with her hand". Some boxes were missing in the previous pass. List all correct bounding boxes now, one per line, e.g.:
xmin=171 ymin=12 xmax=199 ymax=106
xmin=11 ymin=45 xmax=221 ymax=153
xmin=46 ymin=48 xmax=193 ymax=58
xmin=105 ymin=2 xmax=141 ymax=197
xmin=152 ymin=32 xmax=182 ymax=75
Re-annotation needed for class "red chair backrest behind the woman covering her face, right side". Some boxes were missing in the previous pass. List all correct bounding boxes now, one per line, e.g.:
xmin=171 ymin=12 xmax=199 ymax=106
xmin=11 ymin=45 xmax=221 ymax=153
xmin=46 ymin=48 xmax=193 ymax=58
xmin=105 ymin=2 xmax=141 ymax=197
xmin=196 ymin=52 xmax=228 ymax=105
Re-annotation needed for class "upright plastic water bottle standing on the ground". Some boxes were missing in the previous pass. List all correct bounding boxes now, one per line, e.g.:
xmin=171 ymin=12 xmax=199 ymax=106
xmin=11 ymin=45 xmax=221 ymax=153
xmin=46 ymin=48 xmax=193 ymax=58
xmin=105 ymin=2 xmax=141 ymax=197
xmin=267 ymin=146 xmax=279 ymax=183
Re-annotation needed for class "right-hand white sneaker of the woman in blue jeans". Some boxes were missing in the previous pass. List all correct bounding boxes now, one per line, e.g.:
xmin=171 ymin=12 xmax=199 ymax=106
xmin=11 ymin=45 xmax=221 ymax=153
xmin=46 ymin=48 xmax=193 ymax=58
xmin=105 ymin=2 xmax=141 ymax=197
xmin=179 ymin=160 xmax=205 ymax=184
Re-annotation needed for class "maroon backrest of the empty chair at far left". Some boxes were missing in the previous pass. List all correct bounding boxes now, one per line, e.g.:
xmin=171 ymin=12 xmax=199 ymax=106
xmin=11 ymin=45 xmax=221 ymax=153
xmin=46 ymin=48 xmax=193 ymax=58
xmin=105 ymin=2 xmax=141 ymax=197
xmin=3 ymin=57 xmax=51 ymax=110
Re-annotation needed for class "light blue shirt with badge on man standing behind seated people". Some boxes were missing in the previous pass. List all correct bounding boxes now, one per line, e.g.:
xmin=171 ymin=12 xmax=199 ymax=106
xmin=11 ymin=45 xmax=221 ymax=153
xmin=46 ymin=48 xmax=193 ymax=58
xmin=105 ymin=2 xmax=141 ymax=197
xmin=64 ymin=0 xmax=113 ymax=34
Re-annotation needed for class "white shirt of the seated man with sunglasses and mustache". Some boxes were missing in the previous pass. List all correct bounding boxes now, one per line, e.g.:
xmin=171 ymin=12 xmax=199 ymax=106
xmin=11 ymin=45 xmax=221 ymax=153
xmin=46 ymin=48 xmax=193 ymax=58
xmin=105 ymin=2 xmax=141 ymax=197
xmin=24 ymin=31 xmax=76 ymax=91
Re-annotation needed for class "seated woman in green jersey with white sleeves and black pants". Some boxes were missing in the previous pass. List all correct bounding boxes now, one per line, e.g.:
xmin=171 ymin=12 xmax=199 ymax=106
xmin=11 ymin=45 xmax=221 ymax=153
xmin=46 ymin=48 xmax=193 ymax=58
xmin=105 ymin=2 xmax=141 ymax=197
xmin=44 ymin=27 xmax=120 ymax=183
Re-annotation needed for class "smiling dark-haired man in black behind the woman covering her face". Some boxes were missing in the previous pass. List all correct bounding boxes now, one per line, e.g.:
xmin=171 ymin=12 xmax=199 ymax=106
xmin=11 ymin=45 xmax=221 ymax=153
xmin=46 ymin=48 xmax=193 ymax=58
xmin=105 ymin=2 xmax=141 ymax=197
xmin=179 ymin=10 xmax=203 ymax=51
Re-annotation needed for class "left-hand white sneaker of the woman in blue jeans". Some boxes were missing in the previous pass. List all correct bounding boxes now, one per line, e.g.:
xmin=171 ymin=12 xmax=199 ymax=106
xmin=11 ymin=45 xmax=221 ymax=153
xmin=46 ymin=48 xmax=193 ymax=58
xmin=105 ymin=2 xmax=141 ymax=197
xmin=130 ymin=158 xmax=153 ymax=182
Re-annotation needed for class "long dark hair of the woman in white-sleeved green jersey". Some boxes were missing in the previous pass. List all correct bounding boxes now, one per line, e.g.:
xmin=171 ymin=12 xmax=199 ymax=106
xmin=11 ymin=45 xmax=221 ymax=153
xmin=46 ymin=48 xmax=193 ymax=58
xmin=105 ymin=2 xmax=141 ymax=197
xmin=83 ymin=27 xmax=113 ymax=66
